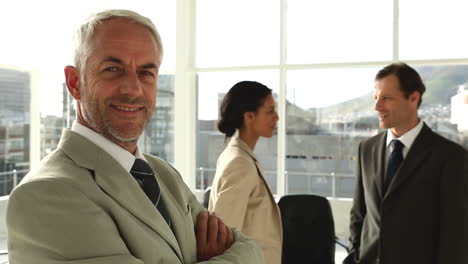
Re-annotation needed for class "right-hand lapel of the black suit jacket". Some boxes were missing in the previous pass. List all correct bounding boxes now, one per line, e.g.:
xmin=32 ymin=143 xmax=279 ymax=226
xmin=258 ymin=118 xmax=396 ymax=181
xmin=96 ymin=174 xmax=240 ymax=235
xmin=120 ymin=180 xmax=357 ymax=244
xmin=387 ymin=124 xmax=434 ymax=194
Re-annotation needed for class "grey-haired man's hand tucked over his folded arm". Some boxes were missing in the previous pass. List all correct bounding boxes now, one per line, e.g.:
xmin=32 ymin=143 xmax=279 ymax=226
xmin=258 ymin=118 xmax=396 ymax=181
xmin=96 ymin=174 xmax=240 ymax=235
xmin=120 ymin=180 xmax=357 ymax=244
xmin=195 ymin=211 xmax=234 ymax=261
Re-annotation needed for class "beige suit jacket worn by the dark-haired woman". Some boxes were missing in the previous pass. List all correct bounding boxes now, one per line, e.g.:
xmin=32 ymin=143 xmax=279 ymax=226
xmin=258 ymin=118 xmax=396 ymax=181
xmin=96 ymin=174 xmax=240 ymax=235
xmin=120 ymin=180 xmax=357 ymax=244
xmin=209 ymin=136 xmax=283 ymax=264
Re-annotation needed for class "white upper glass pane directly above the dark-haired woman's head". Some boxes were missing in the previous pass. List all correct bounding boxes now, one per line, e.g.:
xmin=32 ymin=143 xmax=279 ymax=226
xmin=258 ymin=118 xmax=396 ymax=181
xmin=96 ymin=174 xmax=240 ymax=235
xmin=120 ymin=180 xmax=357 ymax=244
xmin=196 ymin=0 xmax=279 ymax=67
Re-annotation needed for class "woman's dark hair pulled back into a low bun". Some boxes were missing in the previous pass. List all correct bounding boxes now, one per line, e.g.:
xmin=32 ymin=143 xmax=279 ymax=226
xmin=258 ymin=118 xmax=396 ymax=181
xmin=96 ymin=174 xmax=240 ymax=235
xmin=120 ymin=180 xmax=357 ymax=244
xmin=218 ymin=81 xmax=271 ymax=137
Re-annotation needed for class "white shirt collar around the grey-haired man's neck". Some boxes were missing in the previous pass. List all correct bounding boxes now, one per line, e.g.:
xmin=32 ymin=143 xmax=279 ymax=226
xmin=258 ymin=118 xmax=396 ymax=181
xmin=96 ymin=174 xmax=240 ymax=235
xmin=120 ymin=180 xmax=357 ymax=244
xmin=71 ymin=121 xmax=146 ymax=172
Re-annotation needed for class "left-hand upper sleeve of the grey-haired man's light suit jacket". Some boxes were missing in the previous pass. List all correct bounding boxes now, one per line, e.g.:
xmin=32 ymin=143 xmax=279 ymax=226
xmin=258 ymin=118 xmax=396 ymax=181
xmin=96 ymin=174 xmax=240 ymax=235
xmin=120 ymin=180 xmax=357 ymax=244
xmin=6 ymin=180 xmax=143 ymax=264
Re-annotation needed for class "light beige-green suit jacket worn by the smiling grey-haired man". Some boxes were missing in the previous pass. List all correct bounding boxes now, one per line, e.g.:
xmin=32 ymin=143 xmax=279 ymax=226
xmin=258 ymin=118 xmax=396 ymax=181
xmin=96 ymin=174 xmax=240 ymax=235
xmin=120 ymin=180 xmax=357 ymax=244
xmin=6 ymin=130 xmax=263 ymax=264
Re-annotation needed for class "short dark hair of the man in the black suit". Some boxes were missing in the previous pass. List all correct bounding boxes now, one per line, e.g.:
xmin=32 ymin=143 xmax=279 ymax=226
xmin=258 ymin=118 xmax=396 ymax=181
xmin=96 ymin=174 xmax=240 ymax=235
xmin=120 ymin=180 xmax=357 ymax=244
xmin=375 ymin=62 xmax=426 ymax=107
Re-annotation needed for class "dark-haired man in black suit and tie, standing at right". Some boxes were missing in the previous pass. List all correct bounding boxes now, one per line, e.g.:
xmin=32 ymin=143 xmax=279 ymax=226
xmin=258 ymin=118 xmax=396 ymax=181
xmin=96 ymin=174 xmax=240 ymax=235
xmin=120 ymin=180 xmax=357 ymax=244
xmin=343 ymin=63 xmax=468 ymax=264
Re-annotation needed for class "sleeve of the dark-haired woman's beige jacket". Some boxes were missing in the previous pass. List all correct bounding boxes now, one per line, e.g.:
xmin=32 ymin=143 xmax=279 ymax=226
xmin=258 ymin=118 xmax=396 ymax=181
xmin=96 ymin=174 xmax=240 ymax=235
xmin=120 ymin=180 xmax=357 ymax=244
xmin=210 ymin=157 xmax=258 ymax=230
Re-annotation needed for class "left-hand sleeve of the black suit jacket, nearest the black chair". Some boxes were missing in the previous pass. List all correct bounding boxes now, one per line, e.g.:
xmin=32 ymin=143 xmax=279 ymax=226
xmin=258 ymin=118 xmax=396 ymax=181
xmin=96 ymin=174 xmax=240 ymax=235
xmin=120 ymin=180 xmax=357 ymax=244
xmin=343 ymin=143 xmax=366 ymax=264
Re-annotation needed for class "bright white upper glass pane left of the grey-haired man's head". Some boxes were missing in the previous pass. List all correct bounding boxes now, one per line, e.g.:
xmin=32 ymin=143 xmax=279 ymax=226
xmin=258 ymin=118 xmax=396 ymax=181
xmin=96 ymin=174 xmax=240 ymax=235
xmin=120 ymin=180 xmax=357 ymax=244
xmin=0 ymin=0 xmax=105 ymax=70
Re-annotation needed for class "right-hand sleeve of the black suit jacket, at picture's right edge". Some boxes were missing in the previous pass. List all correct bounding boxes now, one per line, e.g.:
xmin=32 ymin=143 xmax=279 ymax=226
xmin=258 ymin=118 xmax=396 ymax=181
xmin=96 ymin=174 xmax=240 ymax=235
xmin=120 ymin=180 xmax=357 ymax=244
xmin=436 ymin=147 xmax=468 ymax=264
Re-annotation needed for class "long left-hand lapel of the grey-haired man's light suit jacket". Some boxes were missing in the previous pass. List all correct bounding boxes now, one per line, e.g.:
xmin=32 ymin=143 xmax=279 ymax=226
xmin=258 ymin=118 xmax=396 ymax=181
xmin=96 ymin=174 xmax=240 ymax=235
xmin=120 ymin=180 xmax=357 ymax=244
xmin=59 ymin=130 xmax=182 ymax=260
